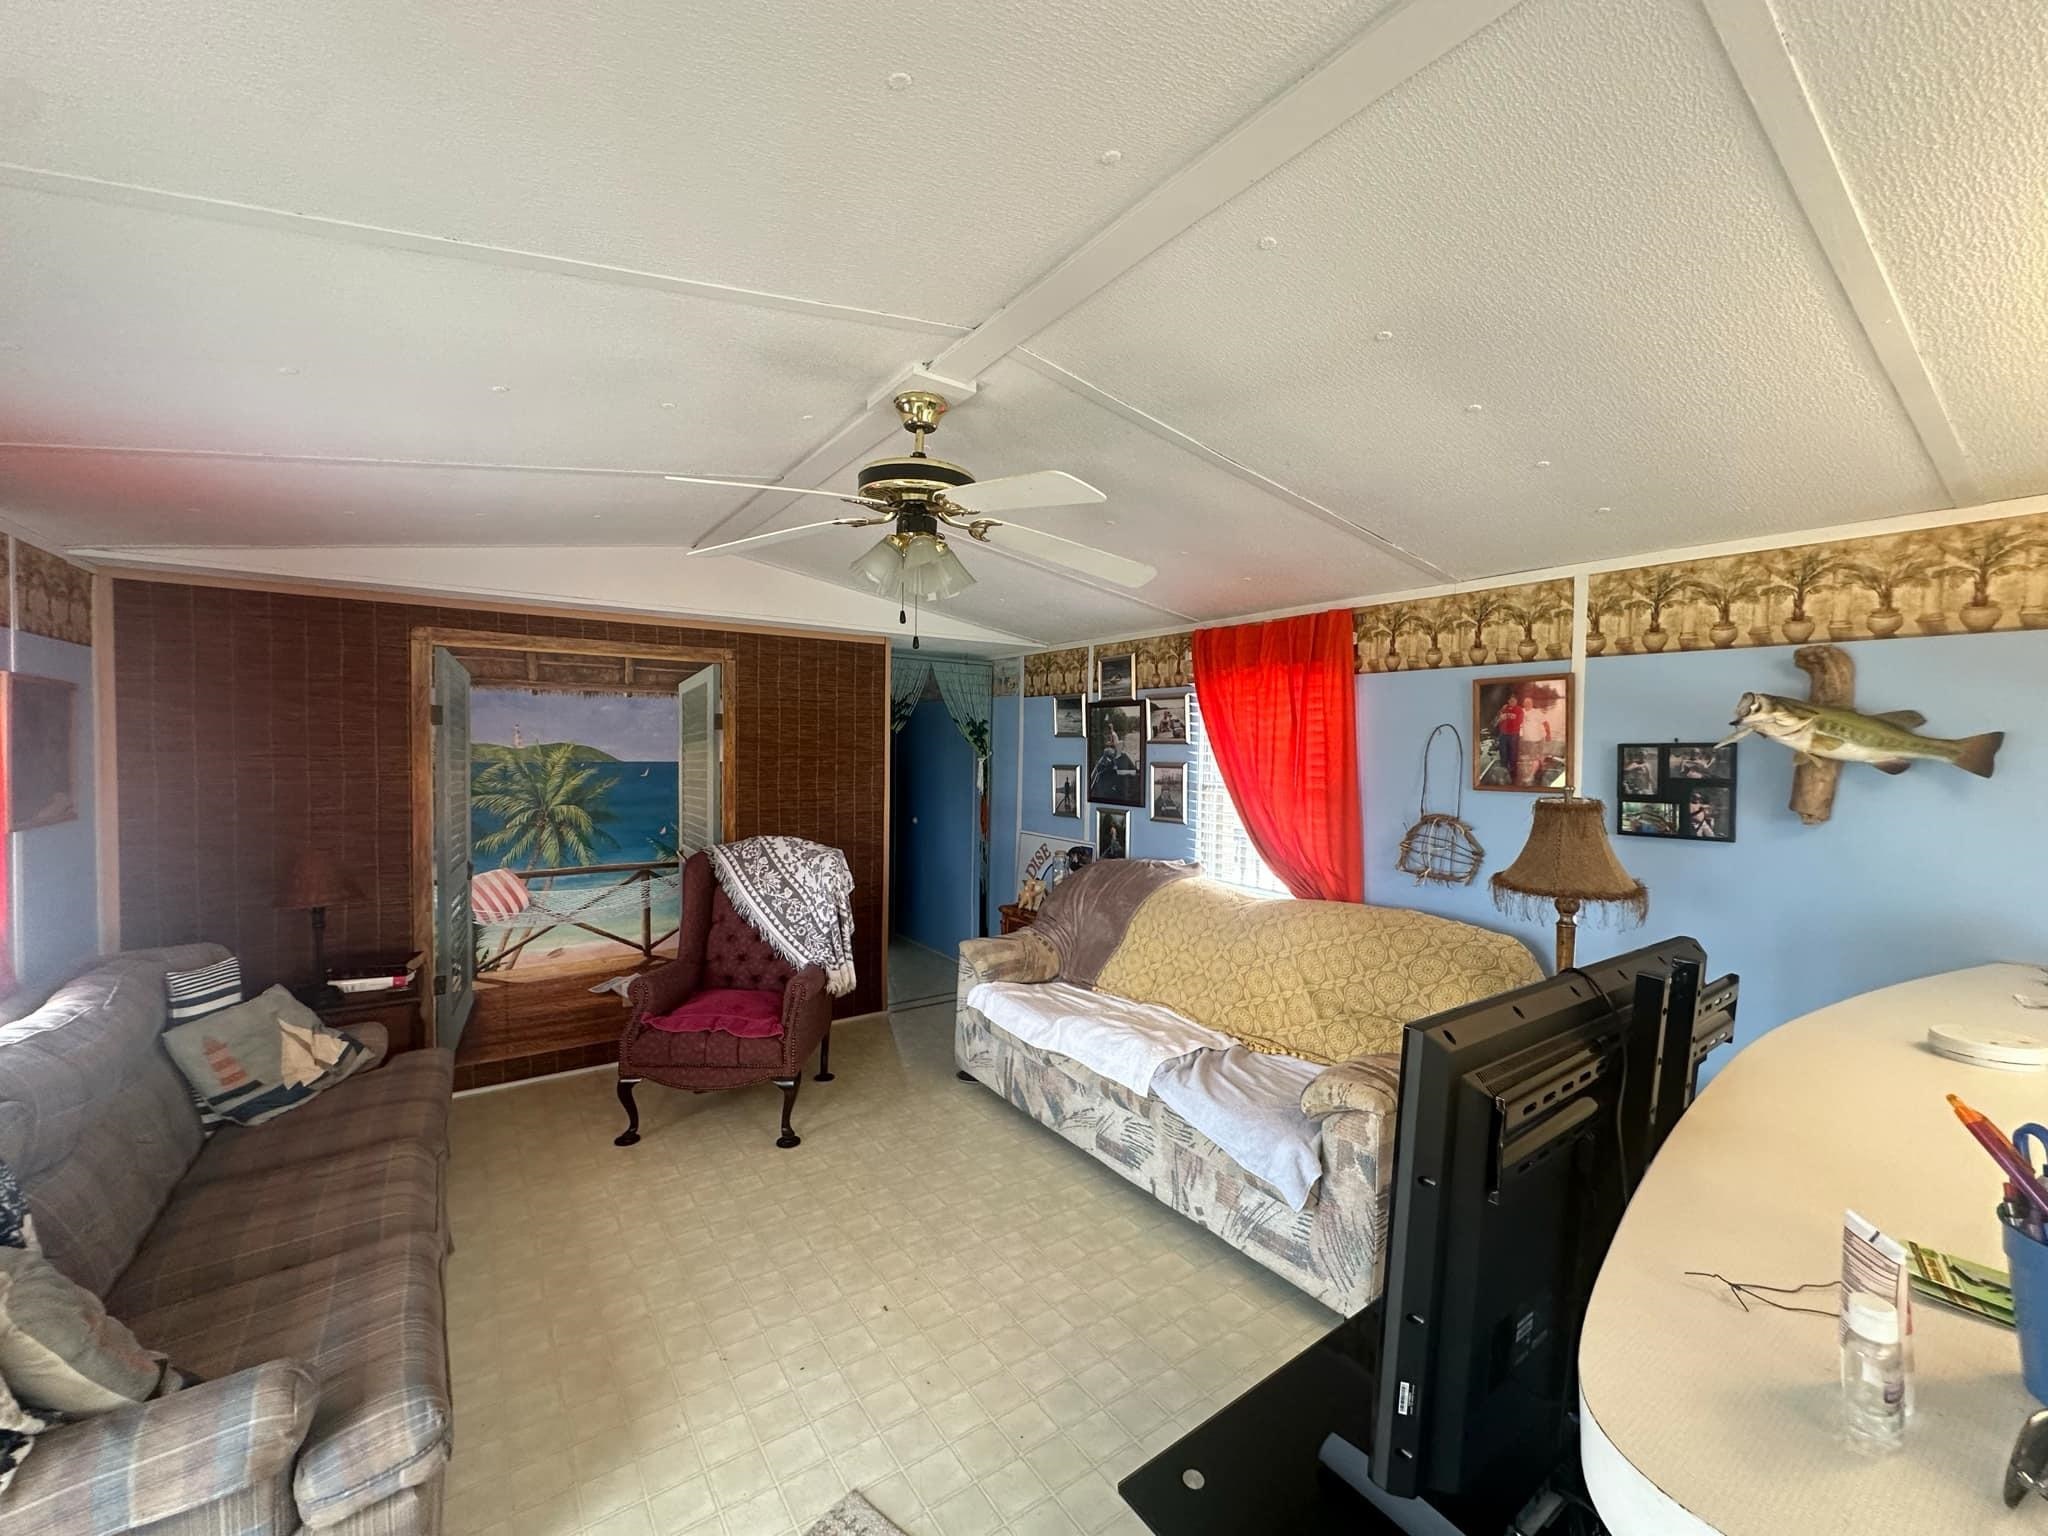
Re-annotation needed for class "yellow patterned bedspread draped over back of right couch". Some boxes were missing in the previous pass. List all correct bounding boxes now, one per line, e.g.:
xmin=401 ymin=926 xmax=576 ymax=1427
xmin=1096 ymin=879 xmax=1542 ymax=1065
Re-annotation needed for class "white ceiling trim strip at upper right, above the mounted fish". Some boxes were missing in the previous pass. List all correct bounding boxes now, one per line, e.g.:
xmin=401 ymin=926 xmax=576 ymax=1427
xmin=1702 ymin=0 xmax=1982 ymax=506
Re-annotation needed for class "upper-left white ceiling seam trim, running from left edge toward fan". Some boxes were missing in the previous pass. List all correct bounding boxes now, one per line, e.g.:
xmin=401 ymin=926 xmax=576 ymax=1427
xmin=0 ymin=162 xmax=967 ymax=336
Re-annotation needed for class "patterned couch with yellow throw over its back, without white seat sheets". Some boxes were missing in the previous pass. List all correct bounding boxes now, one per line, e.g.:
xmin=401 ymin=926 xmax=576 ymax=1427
xmin=954 ymin=860 xmax=1542 ymax=1315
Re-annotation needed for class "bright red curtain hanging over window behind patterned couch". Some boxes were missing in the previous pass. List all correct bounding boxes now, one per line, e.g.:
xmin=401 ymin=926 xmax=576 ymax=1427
xmin=1194 ymin=608 xmax=1366 ymax=901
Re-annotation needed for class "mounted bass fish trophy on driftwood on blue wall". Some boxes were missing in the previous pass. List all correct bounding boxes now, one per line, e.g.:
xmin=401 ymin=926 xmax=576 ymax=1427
xmin=1718 ymin=645 xmax=2005 ymax=827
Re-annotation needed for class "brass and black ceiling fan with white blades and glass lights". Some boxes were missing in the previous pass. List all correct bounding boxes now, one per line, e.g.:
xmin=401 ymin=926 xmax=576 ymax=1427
xmin=664 ymin=389 xmax=1157 ymax=643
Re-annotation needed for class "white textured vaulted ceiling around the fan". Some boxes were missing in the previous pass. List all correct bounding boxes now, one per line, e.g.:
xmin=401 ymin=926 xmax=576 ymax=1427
xmin=0 ymin=0 xmax=2048 ymax=641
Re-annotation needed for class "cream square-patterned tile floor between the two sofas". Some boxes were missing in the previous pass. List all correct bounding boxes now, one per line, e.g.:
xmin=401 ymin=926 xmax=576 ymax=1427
xmin=446 ymin=1001 xmax=1335 ymax=1536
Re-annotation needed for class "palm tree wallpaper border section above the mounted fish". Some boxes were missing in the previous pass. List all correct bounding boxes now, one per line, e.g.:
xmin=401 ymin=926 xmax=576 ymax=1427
xmin=1585 ymin=514 xmax=2048 ymax=655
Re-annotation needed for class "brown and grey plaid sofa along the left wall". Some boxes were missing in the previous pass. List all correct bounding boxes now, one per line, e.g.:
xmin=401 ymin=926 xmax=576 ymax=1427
xmin=0 ymin=944 xmax=453 ymax=1536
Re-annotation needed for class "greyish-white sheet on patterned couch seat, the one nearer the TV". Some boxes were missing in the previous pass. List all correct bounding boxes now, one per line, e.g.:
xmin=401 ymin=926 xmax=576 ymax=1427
xmin=1153 ymin=1044 xmax=1323 ymax=1210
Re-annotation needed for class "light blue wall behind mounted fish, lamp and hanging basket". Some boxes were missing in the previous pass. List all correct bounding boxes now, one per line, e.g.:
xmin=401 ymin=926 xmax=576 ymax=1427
xmin=1358 ymin=633 xmax=2048 ymax=1061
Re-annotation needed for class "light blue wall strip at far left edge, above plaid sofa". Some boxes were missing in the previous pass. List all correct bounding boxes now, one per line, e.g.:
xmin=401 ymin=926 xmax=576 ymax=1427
xmin=0 ymin=631 xmax=100 ymax=985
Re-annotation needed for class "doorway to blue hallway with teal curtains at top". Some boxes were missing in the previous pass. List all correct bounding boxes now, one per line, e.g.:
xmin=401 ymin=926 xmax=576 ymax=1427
xmin=889 ymin=651 xmax=993 ymax=1008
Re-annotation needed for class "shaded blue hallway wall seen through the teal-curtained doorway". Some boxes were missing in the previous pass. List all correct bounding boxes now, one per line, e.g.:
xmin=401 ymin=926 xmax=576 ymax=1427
xmin=889 ymin=698 xmax=979 ymax=954
